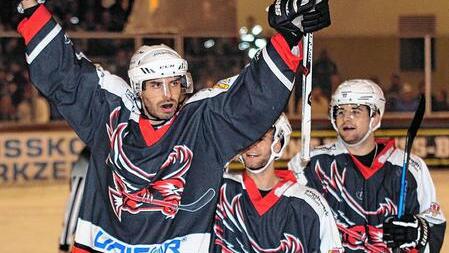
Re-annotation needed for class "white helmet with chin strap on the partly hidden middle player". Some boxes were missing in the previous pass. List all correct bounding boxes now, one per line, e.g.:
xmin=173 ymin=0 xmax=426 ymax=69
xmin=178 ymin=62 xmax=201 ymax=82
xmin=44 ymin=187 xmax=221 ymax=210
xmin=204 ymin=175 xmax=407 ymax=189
xmin=240 ymin=113 xmax=292 ymax=174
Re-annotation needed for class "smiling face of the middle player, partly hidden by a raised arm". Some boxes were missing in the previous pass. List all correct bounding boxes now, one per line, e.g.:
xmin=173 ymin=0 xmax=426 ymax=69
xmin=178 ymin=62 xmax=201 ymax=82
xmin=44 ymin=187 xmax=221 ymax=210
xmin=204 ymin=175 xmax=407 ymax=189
xmin=242 ymin=130 xmax=280 ymax=170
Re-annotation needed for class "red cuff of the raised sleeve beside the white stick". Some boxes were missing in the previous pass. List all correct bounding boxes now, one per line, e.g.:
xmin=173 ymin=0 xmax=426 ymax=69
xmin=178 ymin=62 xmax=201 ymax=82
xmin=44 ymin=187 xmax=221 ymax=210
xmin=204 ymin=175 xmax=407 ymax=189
xmin=271 ymin=33 xmax=303 ymax=72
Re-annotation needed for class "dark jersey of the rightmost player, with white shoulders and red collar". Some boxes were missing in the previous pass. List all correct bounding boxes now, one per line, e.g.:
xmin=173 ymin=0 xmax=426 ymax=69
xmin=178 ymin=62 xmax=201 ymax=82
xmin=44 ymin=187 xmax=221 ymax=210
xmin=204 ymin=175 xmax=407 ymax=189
xmin=289 ymin=139 xmax=446 ymax=253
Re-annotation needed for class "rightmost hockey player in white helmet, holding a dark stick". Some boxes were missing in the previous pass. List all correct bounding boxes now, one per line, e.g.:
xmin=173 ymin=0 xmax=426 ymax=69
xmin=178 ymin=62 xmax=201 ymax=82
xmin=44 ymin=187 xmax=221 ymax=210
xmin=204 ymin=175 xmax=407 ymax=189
xmin=289 ymin=79 xmax=446 ymax=252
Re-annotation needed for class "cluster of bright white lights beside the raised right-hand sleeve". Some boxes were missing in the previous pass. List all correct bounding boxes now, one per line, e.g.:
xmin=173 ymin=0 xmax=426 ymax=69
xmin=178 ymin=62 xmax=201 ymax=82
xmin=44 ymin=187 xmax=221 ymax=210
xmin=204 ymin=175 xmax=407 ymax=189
xmin=238 ymin=25 xmax=267 ymax=58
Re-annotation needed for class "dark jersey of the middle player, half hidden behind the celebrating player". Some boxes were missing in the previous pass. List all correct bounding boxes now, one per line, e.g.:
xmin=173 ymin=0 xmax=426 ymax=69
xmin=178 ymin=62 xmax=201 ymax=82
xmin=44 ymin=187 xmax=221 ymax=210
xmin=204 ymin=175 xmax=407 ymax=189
xmin=211 ymin=170 xmax=343 ymax=253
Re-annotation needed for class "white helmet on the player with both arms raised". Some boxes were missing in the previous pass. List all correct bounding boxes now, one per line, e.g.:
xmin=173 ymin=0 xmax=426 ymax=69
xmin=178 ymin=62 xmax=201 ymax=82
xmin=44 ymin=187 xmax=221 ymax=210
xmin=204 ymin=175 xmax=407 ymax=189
xmin=128 ymin=44 xmax=193 ymax=94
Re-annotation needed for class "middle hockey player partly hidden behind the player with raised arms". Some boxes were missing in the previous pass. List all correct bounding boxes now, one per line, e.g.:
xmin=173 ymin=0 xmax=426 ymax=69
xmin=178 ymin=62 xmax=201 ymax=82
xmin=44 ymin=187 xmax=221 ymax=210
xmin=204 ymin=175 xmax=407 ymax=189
xmin=212 ymin=114 xmax=342 ymax=252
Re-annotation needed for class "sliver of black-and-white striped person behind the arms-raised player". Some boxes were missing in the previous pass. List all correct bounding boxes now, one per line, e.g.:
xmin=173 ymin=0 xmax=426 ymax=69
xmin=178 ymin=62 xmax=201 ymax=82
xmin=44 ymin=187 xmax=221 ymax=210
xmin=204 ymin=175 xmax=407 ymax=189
xmin=59 ymin=147 xmax=90 ymax=253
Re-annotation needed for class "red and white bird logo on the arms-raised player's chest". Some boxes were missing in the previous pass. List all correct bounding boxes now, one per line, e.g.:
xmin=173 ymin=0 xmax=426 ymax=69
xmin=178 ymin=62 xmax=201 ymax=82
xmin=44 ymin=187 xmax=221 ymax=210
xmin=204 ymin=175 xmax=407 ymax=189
xmin=107 ymin=109 xmax=215 ymax=221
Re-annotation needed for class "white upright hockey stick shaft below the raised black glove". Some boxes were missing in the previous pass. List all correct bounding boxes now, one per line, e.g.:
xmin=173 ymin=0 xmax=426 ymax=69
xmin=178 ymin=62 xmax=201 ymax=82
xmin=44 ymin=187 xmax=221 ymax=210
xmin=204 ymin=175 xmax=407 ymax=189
xmin=296 ymin=33 xmax=313 ymax=165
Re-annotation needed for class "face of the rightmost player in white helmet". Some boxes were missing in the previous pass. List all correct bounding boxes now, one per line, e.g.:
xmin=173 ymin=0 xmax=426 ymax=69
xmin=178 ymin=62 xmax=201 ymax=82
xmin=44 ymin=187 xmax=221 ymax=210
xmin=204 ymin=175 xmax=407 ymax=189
xmin=335 ymin=104 xmax=371 ymax=144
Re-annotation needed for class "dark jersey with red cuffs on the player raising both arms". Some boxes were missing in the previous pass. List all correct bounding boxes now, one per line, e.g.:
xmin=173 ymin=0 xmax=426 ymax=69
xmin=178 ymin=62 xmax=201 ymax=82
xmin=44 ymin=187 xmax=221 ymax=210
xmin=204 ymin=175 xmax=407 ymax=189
xmin=18 ymin=6 xmax=301 ymax=253
